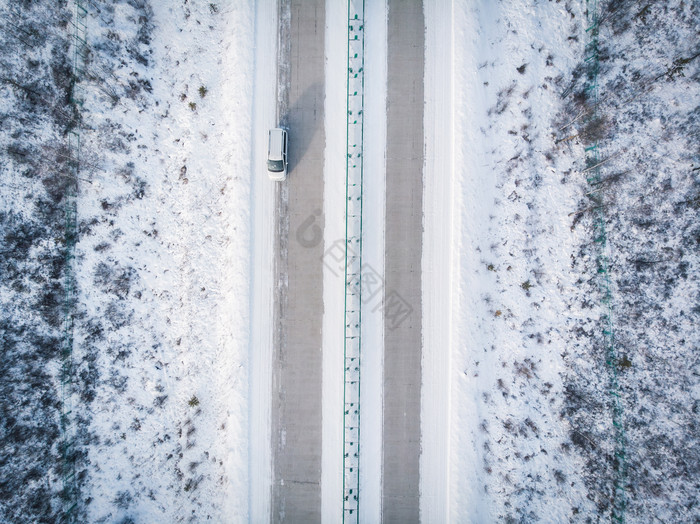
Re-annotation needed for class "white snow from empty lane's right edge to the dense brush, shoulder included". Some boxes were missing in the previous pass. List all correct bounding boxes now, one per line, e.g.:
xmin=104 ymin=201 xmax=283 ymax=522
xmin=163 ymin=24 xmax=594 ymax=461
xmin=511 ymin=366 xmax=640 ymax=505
xmin=421 ymin=1 xmax=600 ymax=523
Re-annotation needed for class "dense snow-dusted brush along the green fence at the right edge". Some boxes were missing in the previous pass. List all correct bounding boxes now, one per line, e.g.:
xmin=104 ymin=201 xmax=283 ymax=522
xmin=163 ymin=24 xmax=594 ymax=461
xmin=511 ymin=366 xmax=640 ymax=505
xmin=561 ymin=1 xmax=700 ymax=522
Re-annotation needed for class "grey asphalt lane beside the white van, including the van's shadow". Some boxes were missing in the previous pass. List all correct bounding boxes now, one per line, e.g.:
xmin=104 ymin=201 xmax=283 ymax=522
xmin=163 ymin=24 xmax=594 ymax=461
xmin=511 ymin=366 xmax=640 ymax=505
xmin=271 ymin=0 xmax=325 ymax=523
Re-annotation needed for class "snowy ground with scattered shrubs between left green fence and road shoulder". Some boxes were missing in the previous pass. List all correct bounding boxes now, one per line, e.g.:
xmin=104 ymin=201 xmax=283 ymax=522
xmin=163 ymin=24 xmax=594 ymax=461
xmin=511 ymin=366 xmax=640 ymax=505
xmin=75 ymin=2 xmax=255 ymax=522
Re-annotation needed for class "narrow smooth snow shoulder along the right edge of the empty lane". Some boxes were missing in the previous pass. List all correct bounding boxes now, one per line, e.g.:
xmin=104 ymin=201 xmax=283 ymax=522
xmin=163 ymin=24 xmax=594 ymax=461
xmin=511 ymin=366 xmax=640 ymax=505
xmin=420 ymin=0 xmax=452 ymax=522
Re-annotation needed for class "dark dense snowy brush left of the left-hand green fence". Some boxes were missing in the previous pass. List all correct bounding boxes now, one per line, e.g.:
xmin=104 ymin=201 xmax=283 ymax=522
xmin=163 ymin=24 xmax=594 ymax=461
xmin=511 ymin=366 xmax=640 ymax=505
xmin=0 ymin=2 xmax=79 ymax=522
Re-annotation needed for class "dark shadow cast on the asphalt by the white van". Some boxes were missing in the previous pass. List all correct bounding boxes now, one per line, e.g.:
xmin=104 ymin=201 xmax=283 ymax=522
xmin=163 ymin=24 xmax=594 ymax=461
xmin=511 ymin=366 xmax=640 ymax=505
xmin=280 ymin=82 xmax=324 ymax=173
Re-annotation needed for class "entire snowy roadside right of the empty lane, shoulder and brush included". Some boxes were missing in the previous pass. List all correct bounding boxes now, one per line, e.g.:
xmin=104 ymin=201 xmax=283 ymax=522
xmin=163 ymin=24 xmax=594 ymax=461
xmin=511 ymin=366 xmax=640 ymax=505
xmin=421 ymin=1 xmax=698 ymax=522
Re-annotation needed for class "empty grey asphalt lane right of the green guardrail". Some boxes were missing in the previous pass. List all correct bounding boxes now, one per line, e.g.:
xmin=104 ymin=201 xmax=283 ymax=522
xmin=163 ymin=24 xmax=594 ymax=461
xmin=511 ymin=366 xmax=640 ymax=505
xmin=382 ymin=0 xmax=425 ymax=524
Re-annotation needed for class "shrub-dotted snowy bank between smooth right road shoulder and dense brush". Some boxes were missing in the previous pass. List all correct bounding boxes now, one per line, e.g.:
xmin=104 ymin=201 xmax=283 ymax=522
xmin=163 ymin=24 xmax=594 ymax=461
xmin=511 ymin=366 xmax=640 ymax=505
xmin=440 ymin=2 xmax=592 ymax=522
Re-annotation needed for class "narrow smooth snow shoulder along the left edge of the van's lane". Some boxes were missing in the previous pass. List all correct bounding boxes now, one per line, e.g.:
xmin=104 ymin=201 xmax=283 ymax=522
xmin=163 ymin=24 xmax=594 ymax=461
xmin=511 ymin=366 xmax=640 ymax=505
xmin=248 ymin=0 xmax=278 ymax=522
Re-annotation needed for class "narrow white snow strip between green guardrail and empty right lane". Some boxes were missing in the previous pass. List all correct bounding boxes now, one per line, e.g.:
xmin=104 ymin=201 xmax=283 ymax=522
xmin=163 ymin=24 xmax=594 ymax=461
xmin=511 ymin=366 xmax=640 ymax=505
xmin=359 ymin=0 xmax=387 ymax=522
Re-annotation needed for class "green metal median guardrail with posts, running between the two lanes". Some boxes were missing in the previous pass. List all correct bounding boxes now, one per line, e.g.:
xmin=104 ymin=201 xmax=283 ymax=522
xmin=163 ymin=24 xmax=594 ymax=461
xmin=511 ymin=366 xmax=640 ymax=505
xmin=343 ymin=0 xmax=365 ymax=522
